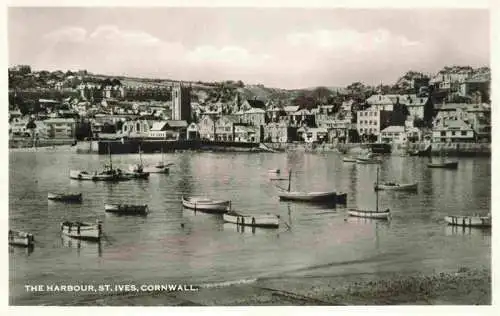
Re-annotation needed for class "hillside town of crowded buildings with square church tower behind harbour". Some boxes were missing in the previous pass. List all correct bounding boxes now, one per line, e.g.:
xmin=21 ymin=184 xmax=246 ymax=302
xmin=9 ymin=65 xmax=491 ymax=147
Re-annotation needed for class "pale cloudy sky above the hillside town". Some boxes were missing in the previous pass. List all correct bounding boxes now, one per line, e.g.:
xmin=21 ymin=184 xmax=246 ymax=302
xmin=8 ymin=7 xmax=490 ymax=89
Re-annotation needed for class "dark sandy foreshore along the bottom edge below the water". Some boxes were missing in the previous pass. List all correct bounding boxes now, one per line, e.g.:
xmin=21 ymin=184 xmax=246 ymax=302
xmin=68 ymin=268 xmax=492 ymax=306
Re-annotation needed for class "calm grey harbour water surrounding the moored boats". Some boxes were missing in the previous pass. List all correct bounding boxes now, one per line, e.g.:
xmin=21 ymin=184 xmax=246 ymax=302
xmin=9 ymin=151 xmax=491 ymax=305
